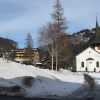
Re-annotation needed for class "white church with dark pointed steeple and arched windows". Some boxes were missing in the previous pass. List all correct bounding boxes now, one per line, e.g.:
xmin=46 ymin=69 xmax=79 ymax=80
xmin=72 ymin=20 xmax=100 ymax=72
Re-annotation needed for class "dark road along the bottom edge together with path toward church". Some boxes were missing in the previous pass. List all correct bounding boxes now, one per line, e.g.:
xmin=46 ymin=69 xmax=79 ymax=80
xmin=0 ymin=74 xmax=100 ymax=100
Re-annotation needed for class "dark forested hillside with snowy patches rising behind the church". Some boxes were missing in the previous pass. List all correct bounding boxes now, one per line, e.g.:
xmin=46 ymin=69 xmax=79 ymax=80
xmin=69 ymin=28 xmax=95 ymax=67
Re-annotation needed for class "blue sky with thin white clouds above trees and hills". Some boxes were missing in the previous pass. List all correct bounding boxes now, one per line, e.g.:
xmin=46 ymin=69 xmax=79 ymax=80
xmin=0 ymin=0 xmax=100 ymax=48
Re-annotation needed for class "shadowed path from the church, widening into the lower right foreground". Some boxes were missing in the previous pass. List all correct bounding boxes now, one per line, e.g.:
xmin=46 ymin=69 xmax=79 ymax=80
xmin=62 ymin=74 xmax=100 ymax=100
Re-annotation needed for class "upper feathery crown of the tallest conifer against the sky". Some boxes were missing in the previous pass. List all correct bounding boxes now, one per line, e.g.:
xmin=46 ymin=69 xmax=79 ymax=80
xmin=51 ymin=0 xmax=68 ymax=36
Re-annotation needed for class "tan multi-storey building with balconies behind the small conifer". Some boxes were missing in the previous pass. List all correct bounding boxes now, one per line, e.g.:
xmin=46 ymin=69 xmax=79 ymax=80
xmin=10 ymin=48 xmax=39 ymax=63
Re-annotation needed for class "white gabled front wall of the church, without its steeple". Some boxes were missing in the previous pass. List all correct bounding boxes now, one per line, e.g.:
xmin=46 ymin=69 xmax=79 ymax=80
xmin=76 ymin=47 xmax=100 ymax=72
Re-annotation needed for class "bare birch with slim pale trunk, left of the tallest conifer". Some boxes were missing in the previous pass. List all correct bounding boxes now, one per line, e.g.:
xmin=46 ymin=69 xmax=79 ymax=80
xmin=38 ymin=22 xmax=55 ymax=70
